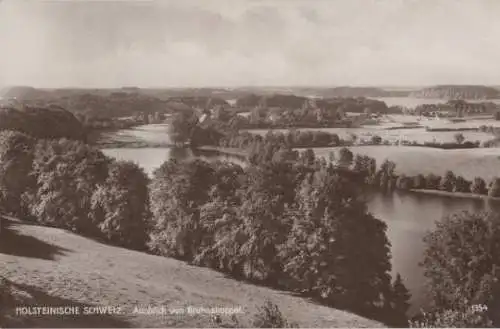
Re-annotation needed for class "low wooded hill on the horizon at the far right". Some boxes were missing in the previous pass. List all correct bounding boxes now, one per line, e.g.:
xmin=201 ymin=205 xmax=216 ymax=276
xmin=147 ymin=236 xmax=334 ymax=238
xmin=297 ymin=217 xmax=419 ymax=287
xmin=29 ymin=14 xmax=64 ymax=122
xmin=410 ymin=85 xmax=500 ymax=100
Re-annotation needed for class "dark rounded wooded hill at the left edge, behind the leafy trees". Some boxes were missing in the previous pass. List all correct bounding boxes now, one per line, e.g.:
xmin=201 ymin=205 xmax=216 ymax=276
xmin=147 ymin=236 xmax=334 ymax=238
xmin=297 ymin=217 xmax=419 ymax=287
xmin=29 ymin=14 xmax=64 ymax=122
xmin=0 ymin=106 xmax=85 ymax=140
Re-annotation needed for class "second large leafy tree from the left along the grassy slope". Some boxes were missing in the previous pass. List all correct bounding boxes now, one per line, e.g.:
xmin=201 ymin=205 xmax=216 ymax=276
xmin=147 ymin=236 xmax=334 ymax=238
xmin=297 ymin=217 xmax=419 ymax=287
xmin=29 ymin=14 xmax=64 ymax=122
xmin=26 ymin=139 xmax=111 ymax=235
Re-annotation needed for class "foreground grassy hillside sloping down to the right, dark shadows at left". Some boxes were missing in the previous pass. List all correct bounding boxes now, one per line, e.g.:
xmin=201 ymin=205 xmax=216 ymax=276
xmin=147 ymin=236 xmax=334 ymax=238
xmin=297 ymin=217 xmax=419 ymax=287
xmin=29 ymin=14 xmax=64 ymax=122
xmin=0 ymin=222 xmax=381 ymax=327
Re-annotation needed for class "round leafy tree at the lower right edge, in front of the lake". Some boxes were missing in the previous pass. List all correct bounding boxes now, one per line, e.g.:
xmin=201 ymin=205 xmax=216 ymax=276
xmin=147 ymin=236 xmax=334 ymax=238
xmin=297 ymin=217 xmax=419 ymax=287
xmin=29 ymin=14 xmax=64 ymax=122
xmin=422 ymin=212 xmax=500 ymax=324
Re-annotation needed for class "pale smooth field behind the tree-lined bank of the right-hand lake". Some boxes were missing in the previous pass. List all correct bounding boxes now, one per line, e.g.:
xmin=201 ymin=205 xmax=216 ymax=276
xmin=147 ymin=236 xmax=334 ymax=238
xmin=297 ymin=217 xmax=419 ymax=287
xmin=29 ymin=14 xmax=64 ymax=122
xmin=314 ymin=146 xmax=500 ymax=182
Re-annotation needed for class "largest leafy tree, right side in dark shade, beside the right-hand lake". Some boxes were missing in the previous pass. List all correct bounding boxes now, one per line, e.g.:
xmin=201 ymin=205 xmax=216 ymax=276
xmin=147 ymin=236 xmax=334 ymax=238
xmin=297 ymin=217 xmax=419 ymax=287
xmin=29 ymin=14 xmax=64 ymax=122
xmin=282 ymin=169 xmax=391 ymax=312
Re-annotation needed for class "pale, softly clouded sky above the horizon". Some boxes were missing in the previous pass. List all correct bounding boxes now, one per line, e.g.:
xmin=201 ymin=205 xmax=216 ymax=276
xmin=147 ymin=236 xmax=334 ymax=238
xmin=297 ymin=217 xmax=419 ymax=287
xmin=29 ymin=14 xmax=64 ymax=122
xmin=0 ymin=0 xmax=500 ymax=87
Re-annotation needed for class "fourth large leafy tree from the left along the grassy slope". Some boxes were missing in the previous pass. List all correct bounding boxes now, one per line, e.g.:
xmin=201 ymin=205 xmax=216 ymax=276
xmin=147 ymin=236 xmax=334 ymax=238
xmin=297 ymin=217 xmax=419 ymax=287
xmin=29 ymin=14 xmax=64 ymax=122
xmin=149 ymin=160 xmax=214 ymax=261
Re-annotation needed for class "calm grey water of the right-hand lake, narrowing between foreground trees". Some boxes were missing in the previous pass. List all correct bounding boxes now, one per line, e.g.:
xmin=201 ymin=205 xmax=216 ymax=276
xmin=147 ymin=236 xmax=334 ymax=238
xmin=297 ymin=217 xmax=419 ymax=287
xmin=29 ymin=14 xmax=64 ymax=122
xmin=368 ymin=193 xmax=500 ymax=312
